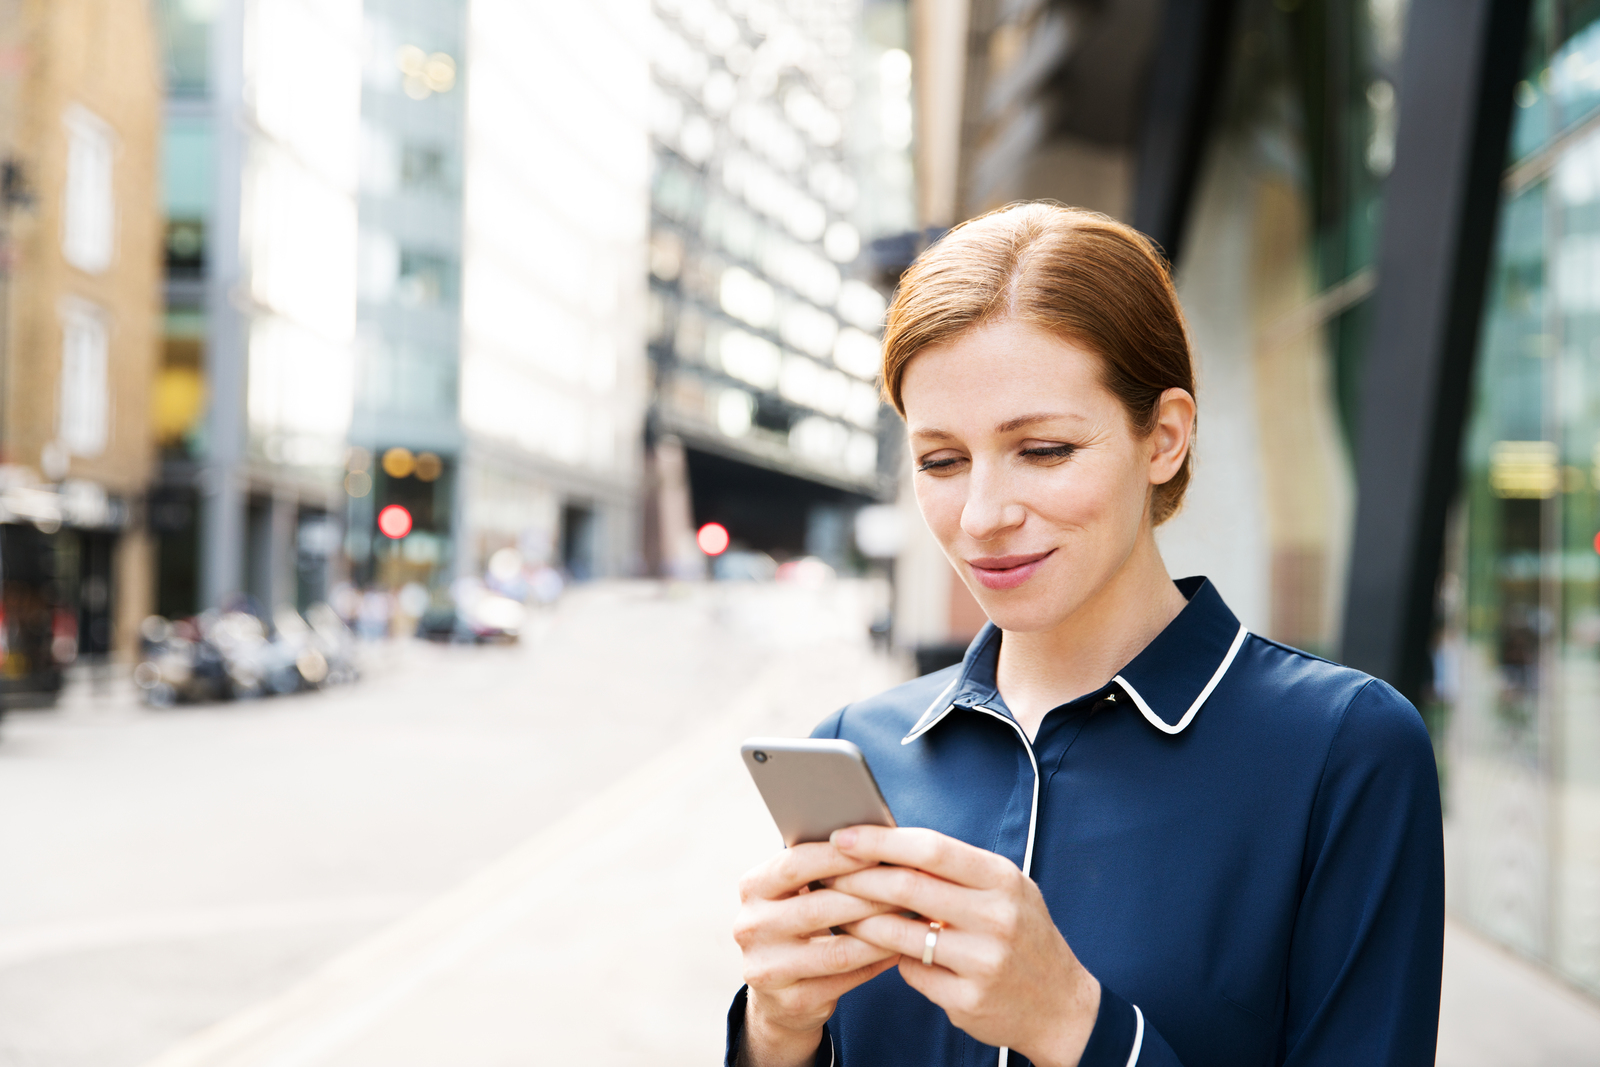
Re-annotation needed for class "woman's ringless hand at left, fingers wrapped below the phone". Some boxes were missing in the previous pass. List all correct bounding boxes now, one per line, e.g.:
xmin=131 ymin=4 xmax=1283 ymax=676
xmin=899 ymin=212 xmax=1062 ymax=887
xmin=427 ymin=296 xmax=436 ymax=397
xmin=733 ymin=843 xmax=899 ymax=1067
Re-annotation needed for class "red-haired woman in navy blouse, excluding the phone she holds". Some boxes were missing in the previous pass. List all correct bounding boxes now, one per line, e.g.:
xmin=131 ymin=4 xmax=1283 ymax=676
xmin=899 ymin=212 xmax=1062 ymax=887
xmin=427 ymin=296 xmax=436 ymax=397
xmin=728 ymin=203 xmax=1443 ymax=1067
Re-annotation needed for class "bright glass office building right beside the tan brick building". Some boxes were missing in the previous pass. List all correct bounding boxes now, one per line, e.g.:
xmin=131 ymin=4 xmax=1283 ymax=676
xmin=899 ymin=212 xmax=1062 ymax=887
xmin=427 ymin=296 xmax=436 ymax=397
xmin=150 ymin=0 xmax=363 ymax=616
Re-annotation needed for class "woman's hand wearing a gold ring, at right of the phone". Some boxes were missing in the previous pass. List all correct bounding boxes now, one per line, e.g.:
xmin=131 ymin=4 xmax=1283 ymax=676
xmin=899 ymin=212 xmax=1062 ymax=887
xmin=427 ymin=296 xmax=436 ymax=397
xmin=829 ymin=825 xmax=1099 ymax=1067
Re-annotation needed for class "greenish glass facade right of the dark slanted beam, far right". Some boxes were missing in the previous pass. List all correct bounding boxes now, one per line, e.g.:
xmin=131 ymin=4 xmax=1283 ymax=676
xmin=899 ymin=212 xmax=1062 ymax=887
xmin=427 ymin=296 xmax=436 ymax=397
xmin=1434 ymin=0 xmax=1600 ymax=993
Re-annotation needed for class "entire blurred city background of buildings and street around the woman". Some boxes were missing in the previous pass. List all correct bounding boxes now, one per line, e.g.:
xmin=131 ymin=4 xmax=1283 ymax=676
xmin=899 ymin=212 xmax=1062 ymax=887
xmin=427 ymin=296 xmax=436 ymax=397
xmin=0 ymin=0 xmax=1600 ymax=1067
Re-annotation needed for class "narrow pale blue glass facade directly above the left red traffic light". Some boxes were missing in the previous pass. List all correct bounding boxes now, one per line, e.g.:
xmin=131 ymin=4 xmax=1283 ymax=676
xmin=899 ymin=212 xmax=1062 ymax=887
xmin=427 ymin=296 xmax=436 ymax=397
xmin=344 ymin=0 xmax=467 ymax=589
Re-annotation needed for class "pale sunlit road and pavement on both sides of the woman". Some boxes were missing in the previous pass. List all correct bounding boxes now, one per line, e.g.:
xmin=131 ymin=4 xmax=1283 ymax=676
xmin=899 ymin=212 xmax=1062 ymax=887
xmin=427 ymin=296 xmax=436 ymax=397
xmin=0 ymin=582 xmax=1600 ymax=1067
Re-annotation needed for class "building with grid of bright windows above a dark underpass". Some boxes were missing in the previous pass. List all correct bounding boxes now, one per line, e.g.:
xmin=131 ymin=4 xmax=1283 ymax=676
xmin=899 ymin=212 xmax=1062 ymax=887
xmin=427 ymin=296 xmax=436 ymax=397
xmin=650 ymin=0 xmax=915 ymax=571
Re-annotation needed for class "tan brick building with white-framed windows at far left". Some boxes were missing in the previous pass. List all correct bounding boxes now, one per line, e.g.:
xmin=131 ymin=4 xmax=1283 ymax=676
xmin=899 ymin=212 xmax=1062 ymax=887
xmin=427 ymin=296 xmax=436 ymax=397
xmin=0 ymin=0 xmax=162 ymax=678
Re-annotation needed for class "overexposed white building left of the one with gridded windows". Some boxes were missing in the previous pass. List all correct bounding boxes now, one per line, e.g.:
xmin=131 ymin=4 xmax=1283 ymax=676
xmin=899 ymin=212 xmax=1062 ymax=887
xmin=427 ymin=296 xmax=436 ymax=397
xmin=459 ymin=0 xmax=650 ymax=579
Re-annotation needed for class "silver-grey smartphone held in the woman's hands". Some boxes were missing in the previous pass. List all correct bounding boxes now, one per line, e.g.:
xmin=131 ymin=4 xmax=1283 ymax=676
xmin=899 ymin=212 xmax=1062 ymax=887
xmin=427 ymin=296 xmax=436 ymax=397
xmin=739 ymin=737 xmax=894 ymax=848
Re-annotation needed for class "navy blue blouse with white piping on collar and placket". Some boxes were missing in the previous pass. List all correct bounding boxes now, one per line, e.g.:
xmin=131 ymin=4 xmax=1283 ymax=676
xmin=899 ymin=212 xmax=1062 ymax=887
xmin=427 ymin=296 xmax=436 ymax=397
xmin=728 ymin=577 xmax=1445 ymax=1067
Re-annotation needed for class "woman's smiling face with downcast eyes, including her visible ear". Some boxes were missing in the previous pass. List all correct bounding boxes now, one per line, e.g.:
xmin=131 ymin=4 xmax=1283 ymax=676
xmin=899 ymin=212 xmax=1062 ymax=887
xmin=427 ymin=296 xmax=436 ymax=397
xmin=901 ymin=322 xmax=1194 ymax=632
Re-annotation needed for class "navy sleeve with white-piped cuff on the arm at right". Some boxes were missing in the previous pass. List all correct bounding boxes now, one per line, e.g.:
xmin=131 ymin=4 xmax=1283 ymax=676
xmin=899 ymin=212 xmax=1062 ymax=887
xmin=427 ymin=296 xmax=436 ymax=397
xmin=1078 ymin=680 xmax=1445 ymax=1067
